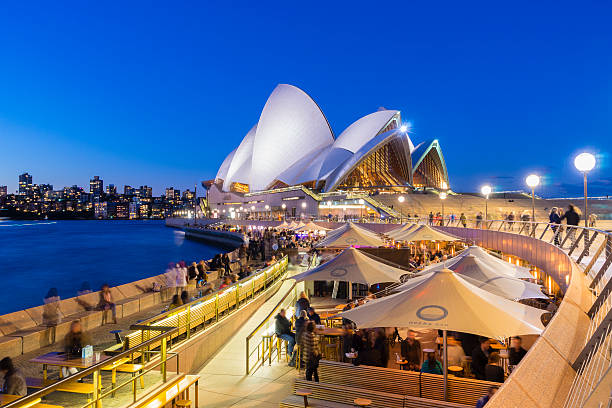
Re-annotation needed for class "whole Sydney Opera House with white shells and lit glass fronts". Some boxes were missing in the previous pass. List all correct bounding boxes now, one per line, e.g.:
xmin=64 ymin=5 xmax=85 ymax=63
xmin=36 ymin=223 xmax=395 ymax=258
xmin=203 ymin=84 xmax=449 ymax=218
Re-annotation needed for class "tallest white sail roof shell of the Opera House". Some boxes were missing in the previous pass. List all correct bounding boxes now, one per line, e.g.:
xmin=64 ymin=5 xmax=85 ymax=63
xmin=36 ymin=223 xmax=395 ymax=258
xmin=249 ymin=84 xmax=334 ymax=191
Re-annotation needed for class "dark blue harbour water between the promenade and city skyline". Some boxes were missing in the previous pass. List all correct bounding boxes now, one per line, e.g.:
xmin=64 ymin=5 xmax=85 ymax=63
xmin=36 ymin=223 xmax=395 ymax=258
xmin=0 ymin=220 xmax=222 ymax=315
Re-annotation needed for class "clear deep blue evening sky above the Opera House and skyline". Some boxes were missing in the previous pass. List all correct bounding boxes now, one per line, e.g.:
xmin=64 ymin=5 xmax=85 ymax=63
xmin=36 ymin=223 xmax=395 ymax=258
xmin=0 ymin=1 xmax=612 ymax=196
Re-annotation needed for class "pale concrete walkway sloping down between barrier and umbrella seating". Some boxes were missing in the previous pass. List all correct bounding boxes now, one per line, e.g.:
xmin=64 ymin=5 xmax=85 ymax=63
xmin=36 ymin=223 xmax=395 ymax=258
xmin=199 ymin=266 xmax=298 ymax=408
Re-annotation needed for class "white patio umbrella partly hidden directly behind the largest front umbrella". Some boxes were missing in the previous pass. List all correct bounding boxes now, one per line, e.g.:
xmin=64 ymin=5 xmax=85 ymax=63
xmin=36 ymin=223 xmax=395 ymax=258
xmin=397 ymin=255 xmax=546 ymax=300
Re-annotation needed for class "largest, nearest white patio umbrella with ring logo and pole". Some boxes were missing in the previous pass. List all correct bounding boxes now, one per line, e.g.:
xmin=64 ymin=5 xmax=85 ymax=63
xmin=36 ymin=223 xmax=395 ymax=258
xmin=340 ymin=269 xmax=545 ymax=399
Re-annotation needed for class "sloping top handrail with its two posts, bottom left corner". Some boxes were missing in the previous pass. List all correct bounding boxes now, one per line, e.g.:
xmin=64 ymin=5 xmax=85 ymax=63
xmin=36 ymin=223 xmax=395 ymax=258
xmin=3 ymin=328 xmax=178 ymax=408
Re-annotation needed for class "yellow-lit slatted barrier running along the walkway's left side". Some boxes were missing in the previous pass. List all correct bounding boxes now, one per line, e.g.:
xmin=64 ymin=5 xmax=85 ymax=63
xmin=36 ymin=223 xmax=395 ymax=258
xmin=125 ymin=256 xmax=289 ymax=348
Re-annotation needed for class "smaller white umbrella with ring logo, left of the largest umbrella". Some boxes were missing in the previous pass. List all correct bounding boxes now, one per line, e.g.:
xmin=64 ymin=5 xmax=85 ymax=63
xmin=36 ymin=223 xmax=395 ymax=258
xmin=291 ymin=247 xmax=410 ymax=286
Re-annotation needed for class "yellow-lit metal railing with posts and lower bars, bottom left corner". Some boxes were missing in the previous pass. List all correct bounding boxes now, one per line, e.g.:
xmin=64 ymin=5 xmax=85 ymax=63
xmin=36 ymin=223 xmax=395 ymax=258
xmin=3 ymin=328 xmax=179 ymax=408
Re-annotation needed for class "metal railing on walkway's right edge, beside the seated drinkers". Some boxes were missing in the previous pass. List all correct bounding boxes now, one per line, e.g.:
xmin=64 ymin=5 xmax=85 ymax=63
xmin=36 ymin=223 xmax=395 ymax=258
xmin=246 ymin=256 xmax=318 ymax=375
